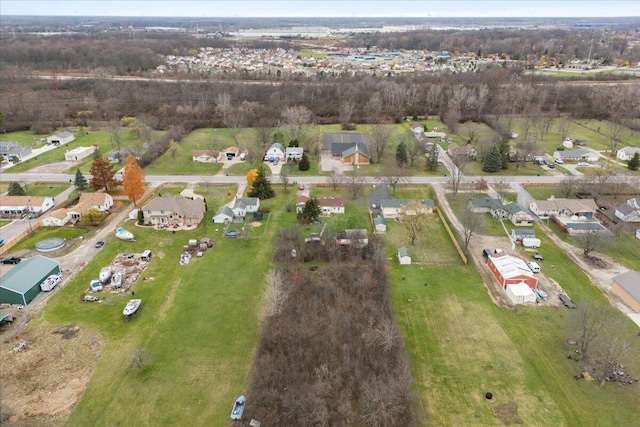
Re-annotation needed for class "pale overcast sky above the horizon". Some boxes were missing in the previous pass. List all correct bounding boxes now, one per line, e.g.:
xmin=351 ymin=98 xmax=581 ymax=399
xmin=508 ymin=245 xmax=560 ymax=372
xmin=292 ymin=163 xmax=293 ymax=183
xmin=0 ymin=0 xmax=640 ymax=18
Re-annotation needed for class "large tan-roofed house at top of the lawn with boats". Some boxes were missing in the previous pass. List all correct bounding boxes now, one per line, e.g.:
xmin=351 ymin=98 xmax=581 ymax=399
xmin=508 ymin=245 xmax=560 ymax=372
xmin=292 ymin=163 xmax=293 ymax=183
xmin=142 ymin=194 xmax=205 ymax=227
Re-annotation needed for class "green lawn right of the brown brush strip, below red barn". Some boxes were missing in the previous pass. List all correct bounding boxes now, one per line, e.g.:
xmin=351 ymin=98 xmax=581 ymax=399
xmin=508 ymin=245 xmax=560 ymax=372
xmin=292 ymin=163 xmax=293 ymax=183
xmin=390 ymin=206 xmax=640 ymax=426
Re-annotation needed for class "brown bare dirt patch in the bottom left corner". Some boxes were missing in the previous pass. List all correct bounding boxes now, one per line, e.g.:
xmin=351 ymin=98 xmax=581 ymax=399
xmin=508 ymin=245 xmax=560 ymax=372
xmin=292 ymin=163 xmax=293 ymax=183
xmin=0 ymin=325 xmax=104 ymax=426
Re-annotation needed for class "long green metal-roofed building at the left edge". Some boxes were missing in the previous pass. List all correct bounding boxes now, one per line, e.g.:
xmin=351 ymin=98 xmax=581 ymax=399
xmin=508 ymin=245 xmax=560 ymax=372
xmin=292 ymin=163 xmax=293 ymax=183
xmin=0 ymin=255 xmax=60 ymax=305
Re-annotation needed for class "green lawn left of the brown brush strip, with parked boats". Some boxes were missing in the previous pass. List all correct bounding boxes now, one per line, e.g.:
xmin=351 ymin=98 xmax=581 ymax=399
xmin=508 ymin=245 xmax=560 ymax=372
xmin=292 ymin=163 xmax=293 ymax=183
xmin=44 ymin=188 xmax=295 ymax=426
